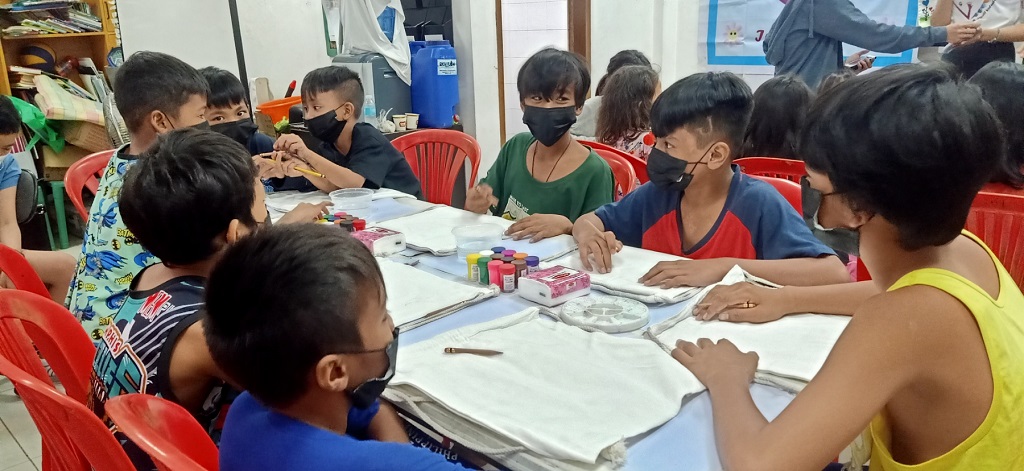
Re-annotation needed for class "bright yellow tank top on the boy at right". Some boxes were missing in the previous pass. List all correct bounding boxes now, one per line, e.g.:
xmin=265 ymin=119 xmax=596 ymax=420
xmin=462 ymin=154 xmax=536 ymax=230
xmin=870 ymin=230 xmax=1024 ymax=471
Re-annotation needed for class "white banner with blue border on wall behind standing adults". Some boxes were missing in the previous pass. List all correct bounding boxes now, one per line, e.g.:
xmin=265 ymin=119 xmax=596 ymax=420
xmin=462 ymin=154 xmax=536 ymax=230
xmin=699 ymin=0 xmax=919 ymax=69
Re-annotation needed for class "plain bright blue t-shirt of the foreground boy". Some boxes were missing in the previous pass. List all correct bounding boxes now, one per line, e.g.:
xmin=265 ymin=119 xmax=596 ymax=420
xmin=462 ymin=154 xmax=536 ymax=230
xmin=220 ymin=392 xmax=466 ymax=471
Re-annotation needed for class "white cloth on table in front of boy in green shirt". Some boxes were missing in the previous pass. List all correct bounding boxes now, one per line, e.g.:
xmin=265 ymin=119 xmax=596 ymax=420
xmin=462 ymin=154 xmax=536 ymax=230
xmin=378 ymin=206 xmax=512 ymax=257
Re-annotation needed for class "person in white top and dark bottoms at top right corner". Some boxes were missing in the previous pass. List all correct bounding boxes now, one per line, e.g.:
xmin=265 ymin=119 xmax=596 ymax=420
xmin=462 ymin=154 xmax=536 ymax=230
xmin=932 ymin=0 xmax=1024 ymax=79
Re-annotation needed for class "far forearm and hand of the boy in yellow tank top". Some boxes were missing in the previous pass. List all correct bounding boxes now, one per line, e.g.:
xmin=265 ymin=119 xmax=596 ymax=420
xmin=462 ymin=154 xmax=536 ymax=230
xmin=693 ymin=282 xmax=882 ymax=324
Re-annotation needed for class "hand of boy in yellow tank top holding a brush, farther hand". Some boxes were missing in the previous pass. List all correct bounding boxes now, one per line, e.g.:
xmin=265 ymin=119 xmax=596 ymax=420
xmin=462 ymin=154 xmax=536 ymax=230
xmin=693 ymin=283 xmax=788 ymax=324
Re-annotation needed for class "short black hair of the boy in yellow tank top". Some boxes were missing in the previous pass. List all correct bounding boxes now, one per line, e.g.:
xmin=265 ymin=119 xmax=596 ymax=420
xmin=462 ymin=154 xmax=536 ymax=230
xmin=799 ymin=65 xmax=1005 ymax=251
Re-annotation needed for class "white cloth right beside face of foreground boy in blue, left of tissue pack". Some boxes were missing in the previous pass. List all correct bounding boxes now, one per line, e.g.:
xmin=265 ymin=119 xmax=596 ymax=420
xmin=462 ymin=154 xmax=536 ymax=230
xmin=377 ymin=259 xmax=498 ymax=331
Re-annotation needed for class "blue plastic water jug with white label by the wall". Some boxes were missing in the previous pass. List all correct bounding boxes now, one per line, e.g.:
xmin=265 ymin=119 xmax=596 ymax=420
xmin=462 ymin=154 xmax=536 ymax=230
xmin=412 ymin=41 xmax=459 ymax=128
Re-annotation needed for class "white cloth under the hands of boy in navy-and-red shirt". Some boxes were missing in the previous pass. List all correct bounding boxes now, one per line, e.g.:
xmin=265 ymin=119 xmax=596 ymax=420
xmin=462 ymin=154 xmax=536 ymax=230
xmin=547 ymin=246 xmax=700 ymax=304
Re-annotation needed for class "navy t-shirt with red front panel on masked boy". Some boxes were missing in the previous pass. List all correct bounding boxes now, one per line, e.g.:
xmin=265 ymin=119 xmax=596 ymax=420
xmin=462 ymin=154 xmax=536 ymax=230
xmin=595 ymin=166 xmax=835 ymax=260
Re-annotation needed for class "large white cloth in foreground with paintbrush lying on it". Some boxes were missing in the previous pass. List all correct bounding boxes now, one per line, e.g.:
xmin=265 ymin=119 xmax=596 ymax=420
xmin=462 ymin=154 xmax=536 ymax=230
xmin=385 ymin=308 xmax=702 ymax=464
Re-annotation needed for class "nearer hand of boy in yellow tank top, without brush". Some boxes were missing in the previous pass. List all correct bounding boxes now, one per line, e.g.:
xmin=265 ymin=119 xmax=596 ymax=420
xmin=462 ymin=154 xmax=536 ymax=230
xmin=672 ymin=339 xmax=758 ymax=390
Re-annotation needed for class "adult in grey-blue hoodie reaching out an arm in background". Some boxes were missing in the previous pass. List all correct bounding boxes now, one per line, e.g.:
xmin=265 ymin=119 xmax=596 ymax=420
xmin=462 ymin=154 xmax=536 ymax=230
xmin=764 ymin=0 xmax=978 ymax=88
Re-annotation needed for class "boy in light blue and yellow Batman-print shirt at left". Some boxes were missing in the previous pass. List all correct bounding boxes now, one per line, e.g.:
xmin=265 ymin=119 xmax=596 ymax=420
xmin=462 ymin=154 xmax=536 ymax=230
xmin=65 ymin=51 xmax=210 ymax=341
